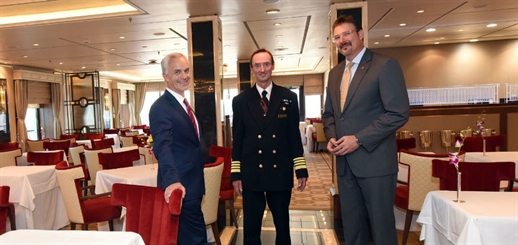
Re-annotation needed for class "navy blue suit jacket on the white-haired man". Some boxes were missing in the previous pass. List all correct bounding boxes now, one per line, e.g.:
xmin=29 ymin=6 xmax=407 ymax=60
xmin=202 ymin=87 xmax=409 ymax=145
xmin=149 ymin=90 xmax=205 ymax=200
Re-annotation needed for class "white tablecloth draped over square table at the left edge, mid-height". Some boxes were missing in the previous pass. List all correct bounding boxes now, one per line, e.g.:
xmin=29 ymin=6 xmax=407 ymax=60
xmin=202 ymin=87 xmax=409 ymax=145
xmin=0 ymin=166 xmax=68 ymax=230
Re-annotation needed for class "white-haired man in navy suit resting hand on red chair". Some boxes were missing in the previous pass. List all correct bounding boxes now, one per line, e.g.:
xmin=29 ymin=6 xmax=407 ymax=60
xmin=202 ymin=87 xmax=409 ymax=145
xmin=149 ymin=53 xmax=207 ymax=245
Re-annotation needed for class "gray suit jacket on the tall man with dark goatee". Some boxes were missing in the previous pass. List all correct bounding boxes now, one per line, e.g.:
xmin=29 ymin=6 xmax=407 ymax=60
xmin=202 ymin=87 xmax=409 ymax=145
xmin=322 ymin=49 xmax=410 ymax=177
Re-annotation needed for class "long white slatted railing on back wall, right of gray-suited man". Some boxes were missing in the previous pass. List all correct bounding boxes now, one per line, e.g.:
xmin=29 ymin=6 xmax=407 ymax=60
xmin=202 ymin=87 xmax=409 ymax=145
xmin=408 ymin=84 xmax=502 ymax=106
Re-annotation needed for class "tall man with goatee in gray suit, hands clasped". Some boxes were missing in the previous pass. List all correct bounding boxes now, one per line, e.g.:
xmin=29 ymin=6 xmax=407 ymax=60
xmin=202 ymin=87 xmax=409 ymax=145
xmin=322 ymin=16 xmax=409 ymax=245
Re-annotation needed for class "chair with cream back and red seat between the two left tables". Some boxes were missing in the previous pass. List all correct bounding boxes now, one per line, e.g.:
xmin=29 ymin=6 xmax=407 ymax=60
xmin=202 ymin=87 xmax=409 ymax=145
xmin=56 ymin=161 xmax=121 ymax=231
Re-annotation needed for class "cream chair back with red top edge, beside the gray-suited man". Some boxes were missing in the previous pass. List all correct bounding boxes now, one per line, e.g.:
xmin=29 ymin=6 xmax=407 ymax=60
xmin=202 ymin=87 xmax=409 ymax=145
xmin=399 ymin=150 xmax=449 ymax=211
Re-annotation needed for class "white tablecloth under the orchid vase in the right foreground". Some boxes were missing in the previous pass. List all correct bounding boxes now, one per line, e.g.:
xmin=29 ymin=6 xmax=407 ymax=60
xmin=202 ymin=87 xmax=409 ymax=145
xmin=417 ymin=191 xmax=518 ymax=245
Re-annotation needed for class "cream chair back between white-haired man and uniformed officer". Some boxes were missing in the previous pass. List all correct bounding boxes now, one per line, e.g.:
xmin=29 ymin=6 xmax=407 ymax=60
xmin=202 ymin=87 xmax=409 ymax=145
xmin=201 ymin=157 xmax=224 ymax=225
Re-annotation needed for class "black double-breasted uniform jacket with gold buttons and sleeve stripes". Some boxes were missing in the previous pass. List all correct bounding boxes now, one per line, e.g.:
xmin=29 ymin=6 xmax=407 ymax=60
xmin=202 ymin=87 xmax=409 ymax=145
xmin=231 ymin=84 xmax=308 ymax=191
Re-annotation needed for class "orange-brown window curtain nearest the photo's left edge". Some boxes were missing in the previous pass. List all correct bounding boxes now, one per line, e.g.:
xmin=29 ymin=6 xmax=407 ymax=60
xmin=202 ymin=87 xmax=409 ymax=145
xmin=14 ymin=80 xmax=29 ymax=152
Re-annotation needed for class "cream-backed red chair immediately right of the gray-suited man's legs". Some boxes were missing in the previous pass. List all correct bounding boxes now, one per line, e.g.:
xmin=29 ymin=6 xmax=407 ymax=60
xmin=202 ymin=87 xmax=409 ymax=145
xmin=394 ymin=150 xmax=449 ymax=245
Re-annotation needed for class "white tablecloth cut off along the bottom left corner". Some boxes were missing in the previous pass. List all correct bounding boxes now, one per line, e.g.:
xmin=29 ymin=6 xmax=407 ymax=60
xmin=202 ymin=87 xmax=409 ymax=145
xmin=0 ymin=230 xmax=145 ymax=245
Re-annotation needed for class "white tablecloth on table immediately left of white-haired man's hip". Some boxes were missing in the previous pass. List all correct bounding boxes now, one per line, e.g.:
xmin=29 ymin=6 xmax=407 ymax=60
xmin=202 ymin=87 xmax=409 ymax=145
xmin=95 ymin=165 xmax=158 ymax=193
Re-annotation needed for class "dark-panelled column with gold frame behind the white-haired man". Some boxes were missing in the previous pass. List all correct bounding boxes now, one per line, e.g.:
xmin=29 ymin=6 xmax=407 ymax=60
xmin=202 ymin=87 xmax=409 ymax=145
xmin=187 ymin=15 xmax=223 ymax=161
